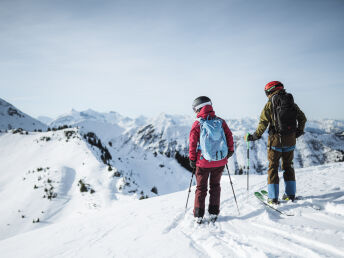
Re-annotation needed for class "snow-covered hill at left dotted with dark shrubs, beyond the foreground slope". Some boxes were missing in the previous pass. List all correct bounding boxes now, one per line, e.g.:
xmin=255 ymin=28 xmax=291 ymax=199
xmin=0 ymin=128 xmax=189 ymax=239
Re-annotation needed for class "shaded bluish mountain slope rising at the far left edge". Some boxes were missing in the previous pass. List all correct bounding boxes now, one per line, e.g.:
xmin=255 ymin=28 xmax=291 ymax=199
xmin=0 ymin=98 xmax=47 ymax=131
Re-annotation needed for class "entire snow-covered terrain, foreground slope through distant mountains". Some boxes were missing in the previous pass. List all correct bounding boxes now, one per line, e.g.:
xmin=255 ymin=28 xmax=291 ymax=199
xmin=0 ymin=99 xmax=344 ymax=258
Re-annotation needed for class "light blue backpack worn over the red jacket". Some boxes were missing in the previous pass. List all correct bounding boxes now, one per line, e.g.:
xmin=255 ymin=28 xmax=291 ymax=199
xmin=197 ymin=117 xmax=228 ymax=161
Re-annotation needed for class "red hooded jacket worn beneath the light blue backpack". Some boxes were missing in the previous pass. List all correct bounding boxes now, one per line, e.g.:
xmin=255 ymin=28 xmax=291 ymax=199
xmin=189 ymin=105 xmax=234 ymax=168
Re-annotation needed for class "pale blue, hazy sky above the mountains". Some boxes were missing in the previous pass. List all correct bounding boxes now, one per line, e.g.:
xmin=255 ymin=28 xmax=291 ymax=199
xmin=0 ymin=0 xmax=344 ymax=119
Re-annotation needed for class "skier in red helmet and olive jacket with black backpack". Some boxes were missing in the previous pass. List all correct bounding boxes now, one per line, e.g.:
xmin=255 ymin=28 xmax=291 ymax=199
xmin=245 ymin=81 xmax=307 ymax=204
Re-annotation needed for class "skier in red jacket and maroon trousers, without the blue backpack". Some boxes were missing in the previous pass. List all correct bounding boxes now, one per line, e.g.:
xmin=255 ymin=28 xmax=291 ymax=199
xmin=189 ymin=96 xmax=234 ymax=223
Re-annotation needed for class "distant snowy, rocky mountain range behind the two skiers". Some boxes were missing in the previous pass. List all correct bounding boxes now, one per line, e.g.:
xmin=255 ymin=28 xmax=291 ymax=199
xmin=52 ymin=107 xmax=344 ymax=173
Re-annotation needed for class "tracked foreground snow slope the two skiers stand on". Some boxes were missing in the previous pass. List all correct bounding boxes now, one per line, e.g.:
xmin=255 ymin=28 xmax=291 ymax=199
xmin=0 ymin=163 xmax=344 ymax=257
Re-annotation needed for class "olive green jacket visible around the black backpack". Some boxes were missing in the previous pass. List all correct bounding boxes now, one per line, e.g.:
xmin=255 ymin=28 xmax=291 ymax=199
xmin=255 ymin=91 xmax=307 ymax=141
